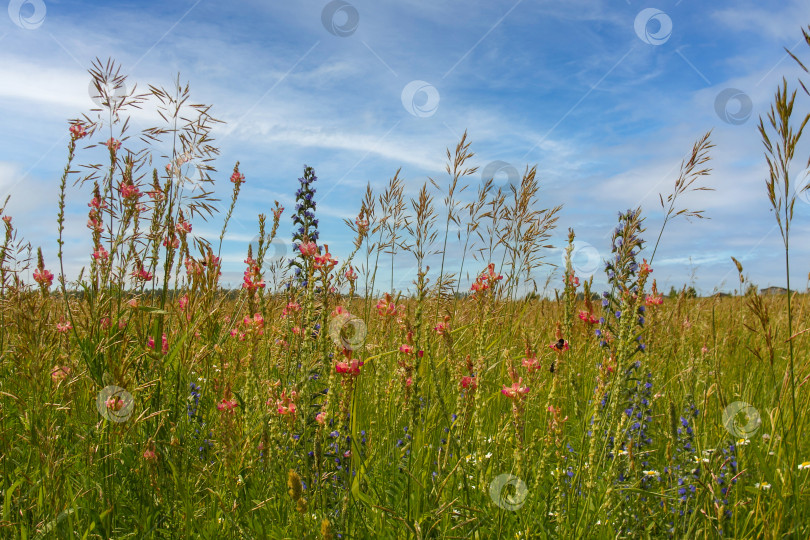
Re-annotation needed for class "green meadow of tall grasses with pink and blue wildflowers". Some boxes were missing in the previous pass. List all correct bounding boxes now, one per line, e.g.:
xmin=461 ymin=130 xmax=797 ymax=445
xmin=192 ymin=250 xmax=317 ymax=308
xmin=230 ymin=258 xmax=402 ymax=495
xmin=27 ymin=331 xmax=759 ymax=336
xmin=0 ymin=47 xmax=810 ymax=539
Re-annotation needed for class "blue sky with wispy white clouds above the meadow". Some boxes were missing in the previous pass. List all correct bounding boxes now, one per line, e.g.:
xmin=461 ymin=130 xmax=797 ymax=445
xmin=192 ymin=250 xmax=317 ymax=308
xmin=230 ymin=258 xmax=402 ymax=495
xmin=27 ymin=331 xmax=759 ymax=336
xmin=0 ymin=0 xmax=810 ymax=292
